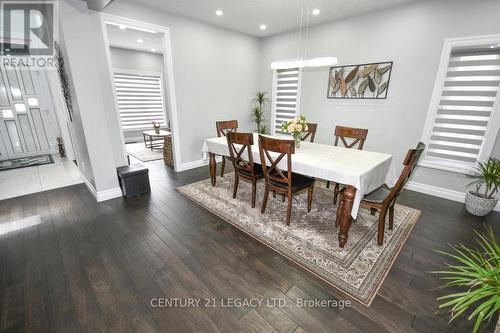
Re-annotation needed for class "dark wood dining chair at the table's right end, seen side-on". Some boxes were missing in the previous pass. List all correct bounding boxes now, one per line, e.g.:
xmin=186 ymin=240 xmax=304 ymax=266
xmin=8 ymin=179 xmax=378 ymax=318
xmin=335 ymin=142 xmax=425 ymax=246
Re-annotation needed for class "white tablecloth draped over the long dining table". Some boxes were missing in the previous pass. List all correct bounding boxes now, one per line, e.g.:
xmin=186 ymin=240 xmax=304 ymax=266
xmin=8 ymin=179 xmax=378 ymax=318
xmin=202 ymin=134 xmax=397 ymax=218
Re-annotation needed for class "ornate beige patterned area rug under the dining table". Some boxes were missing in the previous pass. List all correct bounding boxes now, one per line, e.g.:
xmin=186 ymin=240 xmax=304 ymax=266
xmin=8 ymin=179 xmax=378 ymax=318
xmin=177 ymin=173 xmax=420 ymax=306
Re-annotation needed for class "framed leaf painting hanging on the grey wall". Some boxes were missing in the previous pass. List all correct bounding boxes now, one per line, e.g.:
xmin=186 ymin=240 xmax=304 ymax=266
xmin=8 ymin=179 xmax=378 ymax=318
xmin=326 ymin=61 xmax=392 ymax=99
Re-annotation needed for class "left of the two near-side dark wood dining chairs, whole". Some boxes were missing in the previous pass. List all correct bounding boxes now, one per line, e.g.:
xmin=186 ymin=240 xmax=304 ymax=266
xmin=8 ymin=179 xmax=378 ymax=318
xmin=226 ymin=132 xmax=264 ymax=208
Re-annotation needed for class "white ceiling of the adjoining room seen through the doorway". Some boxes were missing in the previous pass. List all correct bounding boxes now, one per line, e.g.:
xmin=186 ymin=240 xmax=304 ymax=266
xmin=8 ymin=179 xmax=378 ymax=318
xmin=106 ymin=24 xmax=163 ymax=54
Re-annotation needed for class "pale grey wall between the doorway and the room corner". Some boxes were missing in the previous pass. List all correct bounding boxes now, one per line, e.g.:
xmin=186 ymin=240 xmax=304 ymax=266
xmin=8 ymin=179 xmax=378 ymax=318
xmin=104 ymin=1 xmax=259 ymax=163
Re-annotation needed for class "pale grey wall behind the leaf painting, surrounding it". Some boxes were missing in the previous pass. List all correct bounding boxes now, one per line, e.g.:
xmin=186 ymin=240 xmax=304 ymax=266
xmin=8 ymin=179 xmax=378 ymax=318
xmin=260 ymin=1 xmax=500 ymax=192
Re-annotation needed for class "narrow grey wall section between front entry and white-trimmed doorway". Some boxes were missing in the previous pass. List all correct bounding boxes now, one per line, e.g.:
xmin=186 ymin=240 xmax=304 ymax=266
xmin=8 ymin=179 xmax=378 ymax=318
xmin=60 ymin=0 xmax=120 ymax=200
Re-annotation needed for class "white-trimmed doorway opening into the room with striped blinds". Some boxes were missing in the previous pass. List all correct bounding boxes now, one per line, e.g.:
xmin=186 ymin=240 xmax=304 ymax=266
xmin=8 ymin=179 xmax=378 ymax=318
xmin=101 ymin=14 xmax=180 ymax=170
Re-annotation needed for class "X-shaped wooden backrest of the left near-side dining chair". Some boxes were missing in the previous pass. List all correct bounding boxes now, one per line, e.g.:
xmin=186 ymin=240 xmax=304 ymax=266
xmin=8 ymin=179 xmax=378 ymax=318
xmin=226 ymin=131 xmax=254 ymax=175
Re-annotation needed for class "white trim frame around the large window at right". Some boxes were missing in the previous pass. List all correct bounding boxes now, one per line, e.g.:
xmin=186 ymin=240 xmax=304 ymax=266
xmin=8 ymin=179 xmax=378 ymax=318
xmin=418 ymin=35 xmax=500 ymax=174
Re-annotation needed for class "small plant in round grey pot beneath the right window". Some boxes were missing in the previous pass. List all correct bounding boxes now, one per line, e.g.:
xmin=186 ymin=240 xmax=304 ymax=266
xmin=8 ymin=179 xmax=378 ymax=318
xmin=465 ymin=157 xmax=500 ymax=216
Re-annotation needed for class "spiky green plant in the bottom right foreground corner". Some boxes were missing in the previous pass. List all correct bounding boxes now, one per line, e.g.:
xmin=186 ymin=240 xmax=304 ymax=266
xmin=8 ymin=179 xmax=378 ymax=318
xmin=432 ymin=227 xmax=500 ymax=333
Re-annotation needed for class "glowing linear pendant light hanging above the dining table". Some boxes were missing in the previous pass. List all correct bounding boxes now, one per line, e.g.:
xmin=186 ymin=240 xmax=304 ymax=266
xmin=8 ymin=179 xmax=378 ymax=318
xmin=271 ymin=9 xmax=338 ymax=69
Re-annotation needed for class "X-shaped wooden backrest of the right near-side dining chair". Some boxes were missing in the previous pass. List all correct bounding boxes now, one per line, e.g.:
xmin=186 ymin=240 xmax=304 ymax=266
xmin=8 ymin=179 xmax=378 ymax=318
xmin=259 ymin=135 xmax=295 ymax=188
